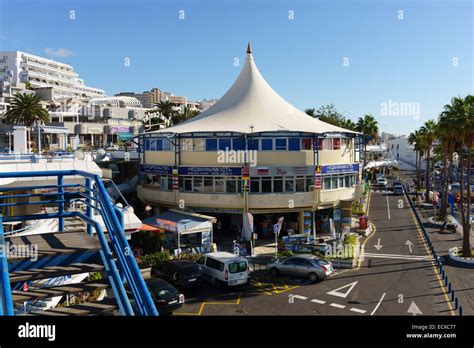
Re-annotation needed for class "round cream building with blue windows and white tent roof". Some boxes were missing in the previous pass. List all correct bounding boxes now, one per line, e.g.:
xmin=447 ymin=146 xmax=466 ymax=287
xmin=138 ymin=44 xmax=363 ymax=240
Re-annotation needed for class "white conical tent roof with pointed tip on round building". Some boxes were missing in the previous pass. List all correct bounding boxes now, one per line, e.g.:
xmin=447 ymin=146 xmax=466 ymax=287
xmin=154 ymin=45 xmax=356 ymax=134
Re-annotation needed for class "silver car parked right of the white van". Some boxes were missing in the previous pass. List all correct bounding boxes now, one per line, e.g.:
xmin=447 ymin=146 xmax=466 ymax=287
xmin=267 ymin=254 xmax=334 ymax=282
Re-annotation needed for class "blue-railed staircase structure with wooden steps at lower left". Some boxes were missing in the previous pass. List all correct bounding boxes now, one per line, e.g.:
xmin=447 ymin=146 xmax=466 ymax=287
xmin=0 ymin=170 xmax=158 ymax=316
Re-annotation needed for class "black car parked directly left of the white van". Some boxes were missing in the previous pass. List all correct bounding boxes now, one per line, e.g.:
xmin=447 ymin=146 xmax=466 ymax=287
xmin=151 ymin=260 xmax=202 ymax=289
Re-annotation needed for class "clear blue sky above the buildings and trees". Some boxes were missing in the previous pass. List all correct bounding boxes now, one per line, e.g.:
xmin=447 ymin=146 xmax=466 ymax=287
xmin=0 ymin=0 xmax=474 ymax=134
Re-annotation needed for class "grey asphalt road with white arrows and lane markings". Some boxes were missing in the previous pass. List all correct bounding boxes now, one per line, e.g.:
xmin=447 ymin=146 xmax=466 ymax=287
xmin=173 ymin=192 xmax=453 ymax=315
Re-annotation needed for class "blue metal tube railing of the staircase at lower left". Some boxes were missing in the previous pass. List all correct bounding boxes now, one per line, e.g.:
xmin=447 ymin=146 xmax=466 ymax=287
xmin=0 ymin=170 xmax=158 ymax=315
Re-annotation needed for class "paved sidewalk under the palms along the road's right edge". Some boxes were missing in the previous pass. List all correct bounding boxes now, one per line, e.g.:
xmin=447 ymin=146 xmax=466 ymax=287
xmin=410 ymin=194 xmax=474 ymax=315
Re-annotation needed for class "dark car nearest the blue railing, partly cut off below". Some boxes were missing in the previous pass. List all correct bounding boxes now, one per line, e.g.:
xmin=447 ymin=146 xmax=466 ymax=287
xmin=146 ymin=278 xmax=184 ymax=315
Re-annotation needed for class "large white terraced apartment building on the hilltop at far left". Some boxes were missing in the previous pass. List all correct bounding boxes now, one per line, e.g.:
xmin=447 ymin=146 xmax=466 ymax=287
xmin=0 ymin=51 xmax=105 ymax=100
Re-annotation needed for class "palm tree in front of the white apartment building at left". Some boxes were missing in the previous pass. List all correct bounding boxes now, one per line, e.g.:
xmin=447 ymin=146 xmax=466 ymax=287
xmin=5 ymin=93 xmax=50 ymax=153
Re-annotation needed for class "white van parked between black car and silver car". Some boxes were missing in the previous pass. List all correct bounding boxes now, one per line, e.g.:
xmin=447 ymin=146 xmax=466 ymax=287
xmin=197 ymin=251 xmax=250 ymax=287
